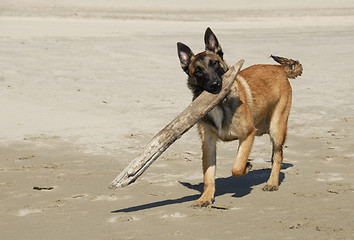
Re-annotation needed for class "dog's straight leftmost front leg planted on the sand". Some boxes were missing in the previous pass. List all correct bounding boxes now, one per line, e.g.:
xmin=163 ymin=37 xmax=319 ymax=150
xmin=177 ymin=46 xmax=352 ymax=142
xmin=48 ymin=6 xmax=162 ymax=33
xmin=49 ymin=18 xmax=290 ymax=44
xmin=194 ymin=129 xmax=217 ymax=207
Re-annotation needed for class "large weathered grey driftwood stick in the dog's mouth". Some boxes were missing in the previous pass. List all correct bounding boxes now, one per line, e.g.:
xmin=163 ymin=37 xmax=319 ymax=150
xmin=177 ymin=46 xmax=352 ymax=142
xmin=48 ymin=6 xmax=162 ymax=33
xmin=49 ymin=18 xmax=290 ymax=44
xmin=109 ymin=60 xmax=244 ymax=189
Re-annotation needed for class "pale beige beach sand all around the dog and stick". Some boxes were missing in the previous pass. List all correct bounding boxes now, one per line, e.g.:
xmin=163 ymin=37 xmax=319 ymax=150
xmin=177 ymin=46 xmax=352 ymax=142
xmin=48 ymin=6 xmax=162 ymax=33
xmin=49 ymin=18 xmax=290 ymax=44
xmin=0 ymin=0 xmax=354 ymax=240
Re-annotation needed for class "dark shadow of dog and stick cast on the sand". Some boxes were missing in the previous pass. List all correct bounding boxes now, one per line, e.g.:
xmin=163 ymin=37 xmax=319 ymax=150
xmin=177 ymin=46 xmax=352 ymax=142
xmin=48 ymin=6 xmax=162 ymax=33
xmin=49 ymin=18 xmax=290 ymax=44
xmin=111 ymin=163 xmax=293 ymax=213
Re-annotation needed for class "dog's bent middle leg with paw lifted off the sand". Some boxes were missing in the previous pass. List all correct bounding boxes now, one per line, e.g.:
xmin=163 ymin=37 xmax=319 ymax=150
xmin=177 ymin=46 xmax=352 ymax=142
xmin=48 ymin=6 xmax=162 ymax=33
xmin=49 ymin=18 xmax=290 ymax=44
xmin=232 ymin=129 xmax=256 ymax=177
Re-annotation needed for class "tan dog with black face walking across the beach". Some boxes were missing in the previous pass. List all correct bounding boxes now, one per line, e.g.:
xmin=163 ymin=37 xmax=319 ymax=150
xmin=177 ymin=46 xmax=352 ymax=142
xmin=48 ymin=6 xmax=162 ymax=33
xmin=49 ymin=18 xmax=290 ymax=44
xmin=177 ymin=28 xmax=303 ymax=207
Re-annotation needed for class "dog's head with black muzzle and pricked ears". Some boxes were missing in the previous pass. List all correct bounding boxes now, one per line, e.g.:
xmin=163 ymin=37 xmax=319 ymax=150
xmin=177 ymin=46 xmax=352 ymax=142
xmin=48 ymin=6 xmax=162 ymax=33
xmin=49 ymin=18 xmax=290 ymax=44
xmin=177 ymin=28 xmax=228 ymax=95
